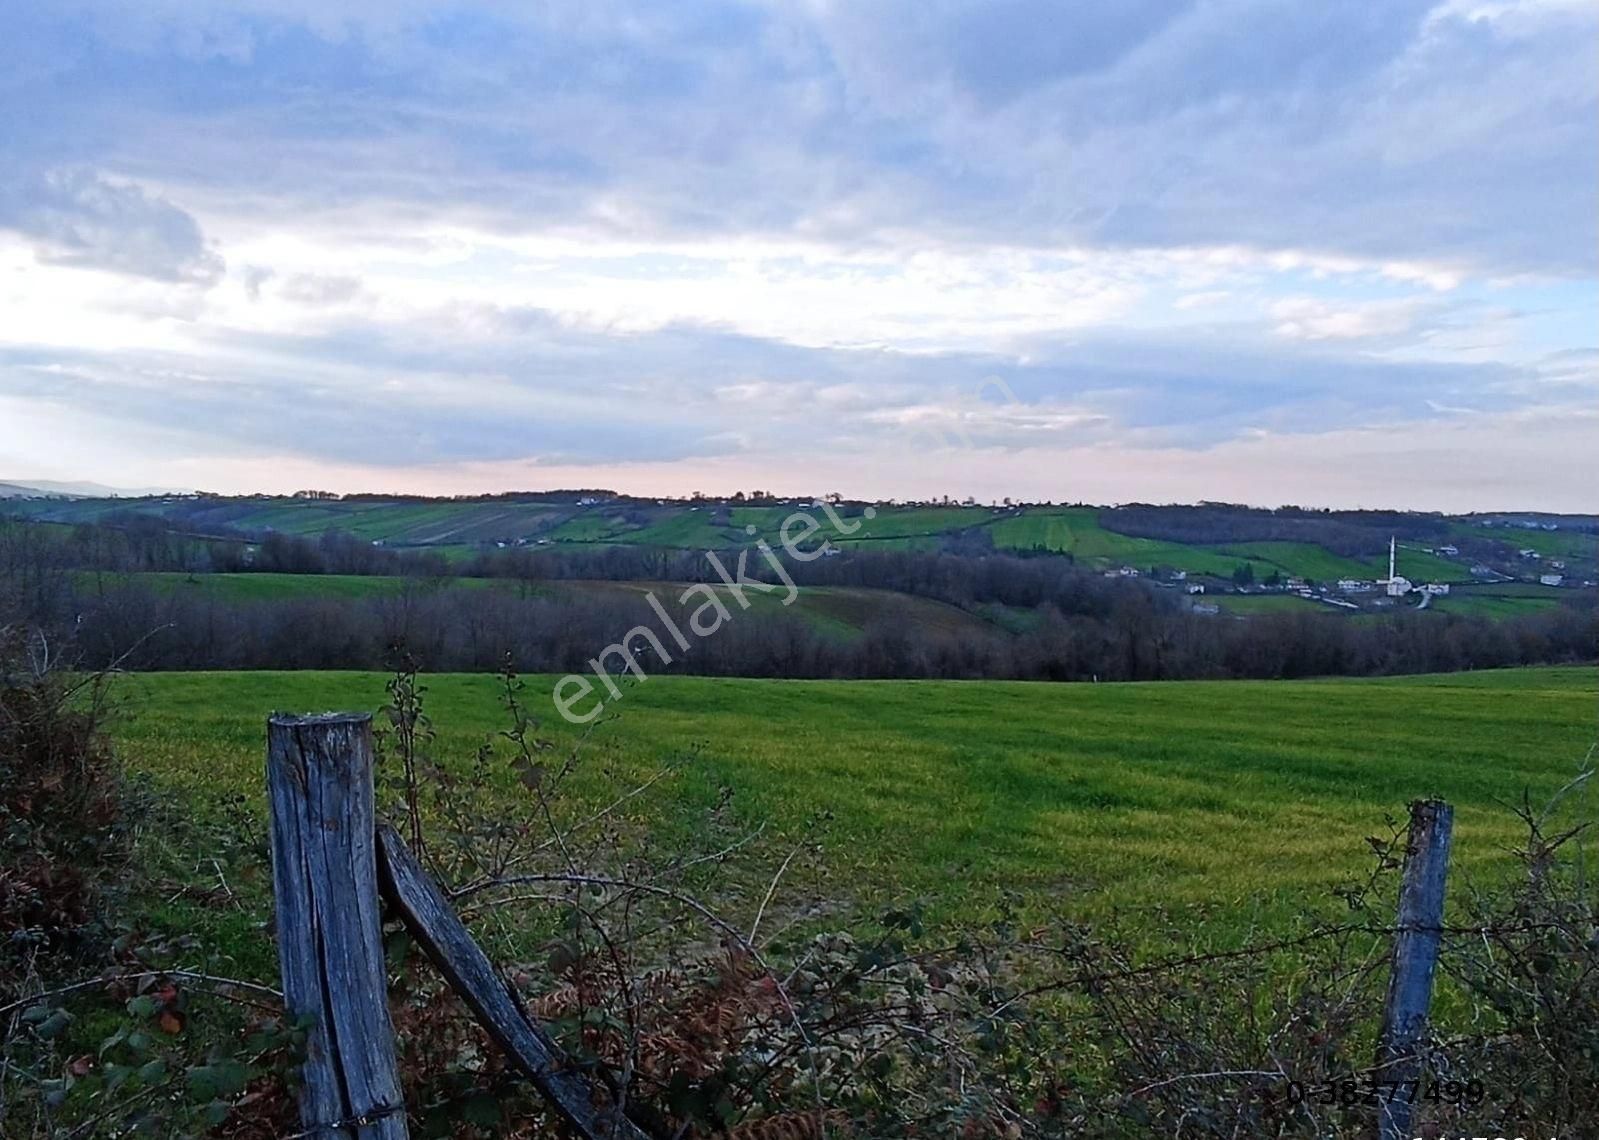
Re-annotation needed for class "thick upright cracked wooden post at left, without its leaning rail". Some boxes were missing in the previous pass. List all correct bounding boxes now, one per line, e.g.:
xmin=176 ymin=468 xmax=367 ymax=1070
xmin=267 ymin=713 xmax=406 ymax=1140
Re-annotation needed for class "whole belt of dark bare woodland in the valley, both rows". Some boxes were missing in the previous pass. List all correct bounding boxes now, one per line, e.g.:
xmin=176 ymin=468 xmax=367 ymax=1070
xmin=0 ymin=514 xmax=1599 ymax=681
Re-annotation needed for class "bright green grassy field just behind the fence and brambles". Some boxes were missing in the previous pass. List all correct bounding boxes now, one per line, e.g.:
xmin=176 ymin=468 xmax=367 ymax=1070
xmin=118 ymin=667 xmax=1599 ymax=926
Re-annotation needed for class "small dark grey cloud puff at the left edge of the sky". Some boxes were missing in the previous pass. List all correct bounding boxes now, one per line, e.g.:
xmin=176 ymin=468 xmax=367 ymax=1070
xmin=0 ymin=169 xmax=224 ymax=286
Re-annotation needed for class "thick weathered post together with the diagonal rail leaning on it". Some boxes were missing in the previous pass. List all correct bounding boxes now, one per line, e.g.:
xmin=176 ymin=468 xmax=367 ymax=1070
xmin=267 ymin=713 xmax=646 ymax=1140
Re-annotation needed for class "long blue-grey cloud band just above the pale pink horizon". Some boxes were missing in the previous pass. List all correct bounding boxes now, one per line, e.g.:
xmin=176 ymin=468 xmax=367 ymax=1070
xmin=0 ymin=300 xmax=1547 ymax=467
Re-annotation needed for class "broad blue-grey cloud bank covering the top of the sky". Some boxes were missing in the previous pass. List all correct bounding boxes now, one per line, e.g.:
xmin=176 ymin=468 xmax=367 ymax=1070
xmin=0 ymin=0 xmax=1599 ymax=273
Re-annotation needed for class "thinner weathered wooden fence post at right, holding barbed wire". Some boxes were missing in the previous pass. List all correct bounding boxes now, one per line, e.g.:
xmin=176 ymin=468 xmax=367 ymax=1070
xmin=1377 ymin=799 xmax=1455 ymax=1140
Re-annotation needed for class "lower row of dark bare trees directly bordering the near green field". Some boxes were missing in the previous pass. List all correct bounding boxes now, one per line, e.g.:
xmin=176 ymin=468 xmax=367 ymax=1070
xmin=21 ymin=566 xmax=1599 ymax=681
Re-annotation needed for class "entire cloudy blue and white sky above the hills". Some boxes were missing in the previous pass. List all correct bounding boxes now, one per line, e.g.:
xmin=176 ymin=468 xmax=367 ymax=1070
xmin=0 ymin=0 xmax=1599 ymax=512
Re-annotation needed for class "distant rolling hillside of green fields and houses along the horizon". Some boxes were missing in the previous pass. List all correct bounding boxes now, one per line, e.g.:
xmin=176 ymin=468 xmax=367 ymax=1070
xmin=5 ymin=492 xmax=1599 ymax=612
